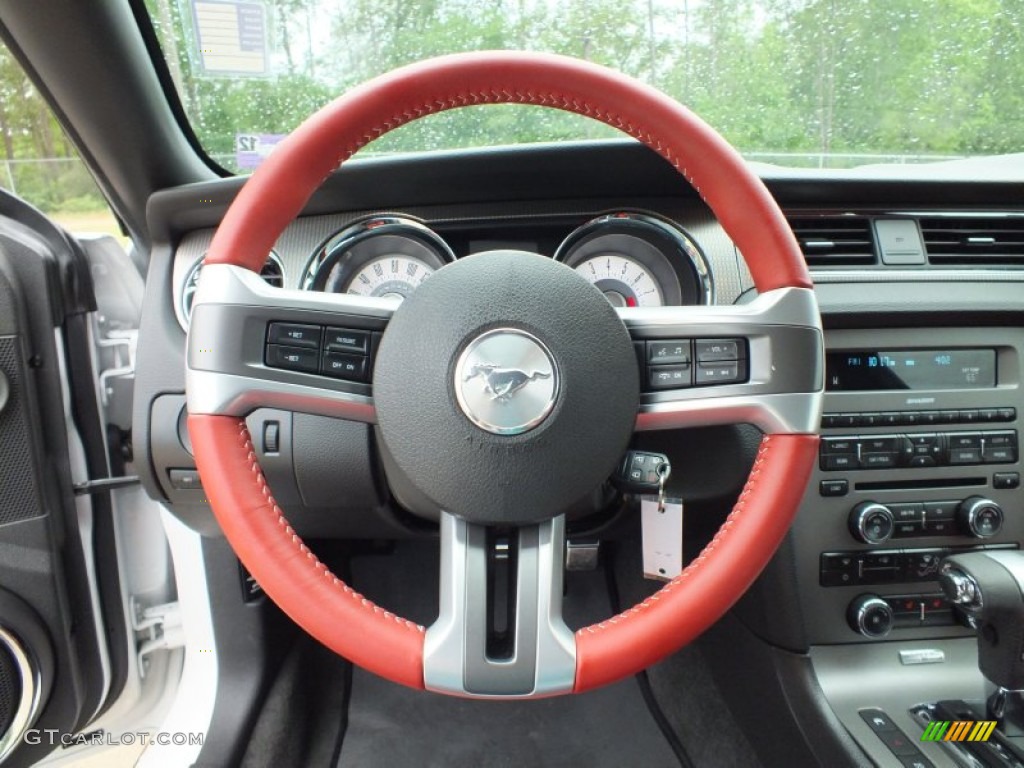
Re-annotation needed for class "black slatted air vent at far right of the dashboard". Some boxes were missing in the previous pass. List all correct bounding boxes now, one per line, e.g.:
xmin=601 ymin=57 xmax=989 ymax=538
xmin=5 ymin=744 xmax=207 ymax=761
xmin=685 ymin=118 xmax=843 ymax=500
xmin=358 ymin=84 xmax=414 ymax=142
xmin=921 ymin=216 xmax=1024 ymax=266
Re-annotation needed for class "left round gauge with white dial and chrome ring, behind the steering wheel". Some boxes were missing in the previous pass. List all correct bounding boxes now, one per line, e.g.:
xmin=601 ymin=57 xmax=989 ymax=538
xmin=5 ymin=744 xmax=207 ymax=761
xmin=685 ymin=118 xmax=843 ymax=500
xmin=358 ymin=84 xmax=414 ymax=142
xmin=302 ymin=215 xmax=455 ymax=299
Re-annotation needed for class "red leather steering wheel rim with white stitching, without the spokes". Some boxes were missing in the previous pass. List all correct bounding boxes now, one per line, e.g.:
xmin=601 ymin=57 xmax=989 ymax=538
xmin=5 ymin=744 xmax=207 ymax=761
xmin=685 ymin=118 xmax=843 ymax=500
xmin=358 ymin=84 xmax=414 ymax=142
xmin=188 ymin=52 xmax=820 ymax=692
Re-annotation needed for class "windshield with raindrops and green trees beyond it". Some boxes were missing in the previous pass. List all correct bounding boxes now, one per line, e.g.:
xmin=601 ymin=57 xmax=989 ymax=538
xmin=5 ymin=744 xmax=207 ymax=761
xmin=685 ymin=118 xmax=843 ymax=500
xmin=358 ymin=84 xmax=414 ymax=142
xmin=146 ymin=0 xmax=1024 ymax=172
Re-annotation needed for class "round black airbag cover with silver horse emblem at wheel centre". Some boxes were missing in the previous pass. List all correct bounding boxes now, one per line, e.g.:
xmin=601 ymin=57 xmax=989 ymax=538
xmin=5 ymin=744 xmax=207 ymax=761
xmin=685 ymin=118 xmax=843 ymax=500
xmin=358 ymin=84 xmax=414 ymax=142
xmin=374 ymin=251 xmax=640 ymax=525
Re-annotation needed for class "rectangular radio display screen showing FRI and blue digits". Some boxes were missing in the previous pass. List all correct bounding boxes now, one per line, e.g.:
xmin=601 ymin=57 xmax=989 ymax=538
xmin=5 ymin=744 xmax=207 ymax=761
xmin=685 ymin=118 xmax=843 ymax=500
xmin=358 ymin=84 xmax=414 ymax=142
xmin=825 ymin=349 xmax=995 ymax=392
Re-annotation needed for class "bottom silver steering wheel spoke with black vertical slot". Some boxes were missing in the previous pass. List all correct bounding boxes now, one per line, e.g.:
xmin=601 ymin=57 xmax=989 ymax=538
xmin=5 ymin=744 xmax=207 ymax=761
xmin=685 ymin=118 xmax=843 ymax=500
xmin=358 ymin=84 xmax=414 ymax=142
xmin=423 ymin=512 xmax=575 ymax=698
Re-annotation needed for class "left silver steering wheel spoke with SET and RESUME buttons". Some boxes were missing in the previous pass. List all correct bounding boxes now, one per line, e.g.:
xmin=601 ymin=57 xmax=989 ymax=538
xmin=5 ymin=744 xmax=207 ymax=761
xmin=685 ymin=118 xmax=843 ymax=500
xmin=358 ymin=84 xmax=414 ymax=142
xmin=185 ymin=264 xmax=391 ymax=423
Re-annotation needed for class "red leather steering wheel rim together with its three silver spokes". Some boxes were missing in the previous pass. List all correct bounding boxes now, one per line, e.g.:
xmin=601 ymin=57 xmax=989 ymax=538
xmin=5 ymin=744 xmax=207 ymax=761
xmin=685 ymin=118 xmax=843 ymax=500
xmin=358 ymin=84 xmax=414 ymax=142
xmin=187 ymin=52 xmax=823 ymax=696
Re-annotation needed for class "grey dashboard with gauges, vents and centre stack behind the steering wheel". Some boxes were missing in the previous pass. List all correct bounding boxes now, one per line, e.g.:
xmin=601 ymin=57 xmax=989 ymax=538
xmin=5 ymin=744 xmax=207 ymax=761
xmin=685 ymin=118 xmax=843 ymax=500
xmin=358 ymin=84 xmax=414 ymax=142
xmin=135 ymin=144 xmax=1024 ymax=764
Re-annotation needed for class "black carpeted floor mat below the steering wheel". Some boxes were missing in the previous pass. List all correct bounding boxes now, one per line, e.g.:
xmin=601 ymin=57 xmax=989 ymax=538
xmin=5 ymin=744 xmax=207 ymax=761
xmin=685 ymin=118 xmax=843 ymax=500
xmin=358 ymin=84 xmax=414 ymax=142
xmin=338 ymin=547 xmax=679 ymax=768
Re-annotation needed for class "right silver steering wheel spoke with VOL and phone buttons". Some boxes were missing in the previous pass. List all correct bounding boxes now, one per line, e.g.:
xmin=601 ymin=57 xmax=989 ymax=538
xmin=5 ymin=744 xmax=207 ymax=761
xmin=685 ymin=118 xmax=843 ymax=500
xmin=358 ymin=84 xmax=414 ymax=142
xmin=617 ymin=288 xmax=824 ymax=434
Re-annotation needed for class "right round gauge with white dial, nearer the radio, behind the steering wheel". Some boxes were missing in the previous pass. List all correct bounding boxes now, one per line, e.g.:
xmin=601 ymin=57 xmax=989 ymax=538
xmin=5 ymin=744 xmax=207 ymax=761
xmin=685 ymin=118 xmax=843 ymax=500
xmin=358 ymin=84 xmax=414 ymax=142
xmin=555 ymin=213 xmax=713 ymax=307
